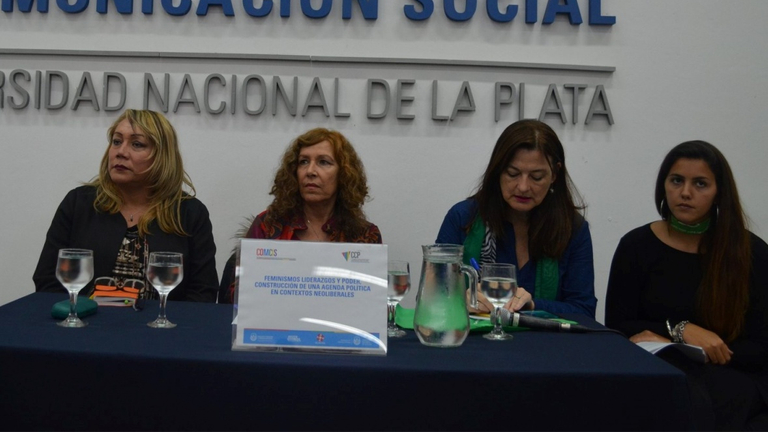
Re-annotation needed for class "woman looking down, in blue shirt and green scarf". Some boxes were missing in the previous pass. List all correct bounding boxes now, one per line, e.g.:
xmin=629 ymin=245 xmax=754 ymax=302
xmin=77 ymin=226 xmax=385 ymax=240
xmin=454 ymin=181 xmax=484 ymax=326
xmin=436 ymin=120 xmax=597 ymax=318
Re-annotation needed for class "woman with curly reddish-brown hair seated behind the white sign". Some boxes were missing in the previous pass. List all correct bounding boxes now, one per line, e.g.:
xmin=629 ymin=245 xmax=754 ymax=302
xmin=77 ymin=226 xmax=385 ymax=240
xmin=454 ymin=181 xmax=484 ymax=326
xmin=219 ymin=128 xmax=381 ymax=303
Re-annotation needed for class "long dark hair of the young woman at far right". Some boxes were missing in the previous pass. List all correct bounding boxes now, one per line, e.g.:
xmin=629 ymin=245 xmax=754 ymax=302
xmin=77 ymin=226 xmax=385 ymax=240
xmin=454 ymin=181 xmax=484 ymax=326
xmin=655 ymin=141 xmax=752 ymax=342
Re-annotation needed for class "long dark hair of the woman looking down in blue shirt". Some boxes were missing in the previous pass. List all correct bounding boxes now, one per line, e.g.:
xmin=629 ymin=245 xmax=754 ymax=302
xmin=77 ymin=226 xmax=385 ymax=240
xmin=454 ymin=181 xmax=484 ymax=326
xmin=470 ymin=120 xmax=583 ymax=259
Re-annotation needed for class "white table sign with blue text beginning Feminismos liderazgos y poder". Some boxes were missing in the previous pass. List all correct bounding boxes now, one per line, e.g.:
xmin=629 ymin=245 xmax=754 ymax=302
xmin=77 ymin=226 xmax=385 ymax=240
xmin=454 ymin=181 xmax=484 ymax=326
xmin=232 ymin=239 xmax=387 ymax=355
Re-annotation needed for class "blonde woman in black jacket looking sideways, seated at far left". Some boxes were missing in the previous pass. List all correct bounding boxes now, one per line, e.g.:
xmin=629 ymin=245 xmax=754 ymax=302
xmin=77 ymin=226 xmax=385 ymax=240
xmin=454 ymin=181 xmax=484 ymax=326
xmin=33 ymin=109 xmax=218 ymax=302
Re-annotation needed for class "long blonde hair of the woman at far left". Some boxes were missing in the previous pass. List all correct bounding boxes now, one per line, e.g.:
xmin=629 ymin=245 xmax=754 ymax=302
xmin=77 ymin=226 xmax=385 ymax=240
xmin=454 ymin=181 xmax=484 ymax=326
xmin=89 ymin=109 xmax=195 ymax=236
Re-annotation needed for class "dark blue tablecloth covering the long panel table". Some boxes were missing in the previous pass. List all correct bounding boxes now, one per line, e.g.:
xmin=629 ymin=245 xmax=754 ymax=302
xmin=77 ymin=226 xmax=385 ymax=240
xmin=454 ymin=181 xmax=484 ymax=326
xmin=0 ymin=292 xmax=691 ymax=430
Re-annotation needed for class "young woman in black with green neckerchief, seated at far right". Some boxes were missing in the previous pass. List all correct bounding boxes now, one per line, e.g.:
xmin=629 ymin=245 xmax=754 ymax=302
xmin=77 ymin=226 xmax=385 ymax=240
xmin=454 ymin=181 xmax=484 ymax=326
xmin=605 ymin=141 xmax=768 ymax=430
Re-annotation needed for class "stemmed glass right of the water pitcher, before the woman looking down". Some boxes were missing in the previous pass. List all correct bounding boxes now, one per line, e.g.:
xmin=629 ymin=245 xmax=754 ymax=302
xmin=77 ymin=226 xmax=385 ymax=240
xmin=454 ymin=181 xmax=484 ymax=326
xmin=480 ymin=263 xmax=517 ymax=340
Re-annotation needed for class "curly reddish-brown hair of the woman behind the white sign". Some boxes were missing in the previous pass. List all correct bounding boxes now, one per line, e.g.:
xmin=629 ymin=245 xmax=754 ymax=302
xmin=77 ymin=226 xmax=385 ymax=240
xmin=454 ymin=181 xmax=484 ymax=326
xmin=264 ymin=128 xmax=368 ymax=238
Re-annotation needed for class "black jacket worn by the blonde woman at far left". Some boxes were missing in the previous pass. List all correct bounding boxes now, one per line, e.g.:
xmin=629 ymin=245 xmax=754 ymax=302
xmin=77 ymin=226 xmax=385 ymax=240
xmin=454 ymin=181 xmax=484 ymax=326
xmin=32 ymin=186 xmax=218 ymax=302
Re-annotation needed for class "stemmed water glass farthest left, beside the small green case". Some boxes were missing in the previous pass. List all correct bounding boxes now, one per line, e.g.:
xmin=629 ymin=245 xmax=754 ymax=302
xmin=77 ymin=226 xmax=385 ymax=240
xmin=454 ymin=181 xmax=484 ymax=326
xmin=56 ymin=249 xmax=93 ymax=328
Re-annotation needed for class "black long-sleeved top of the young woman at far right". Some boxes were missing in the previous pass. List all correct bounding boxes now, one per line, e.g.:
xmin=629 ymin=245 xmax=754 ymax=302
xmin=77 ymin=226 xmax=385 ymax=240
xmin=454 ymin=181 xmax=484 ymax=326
xmin=605 ymin=224 xmax=768 ymax=370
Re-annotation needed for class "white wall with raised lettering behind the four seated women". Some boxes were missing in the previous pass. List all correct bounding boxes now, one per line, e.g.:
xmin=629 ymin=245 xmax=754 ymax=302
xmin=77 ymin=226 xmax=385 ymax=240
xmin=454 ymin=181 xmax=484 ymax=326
xmin=0 ymin=0 xmax=768 ymax=319
